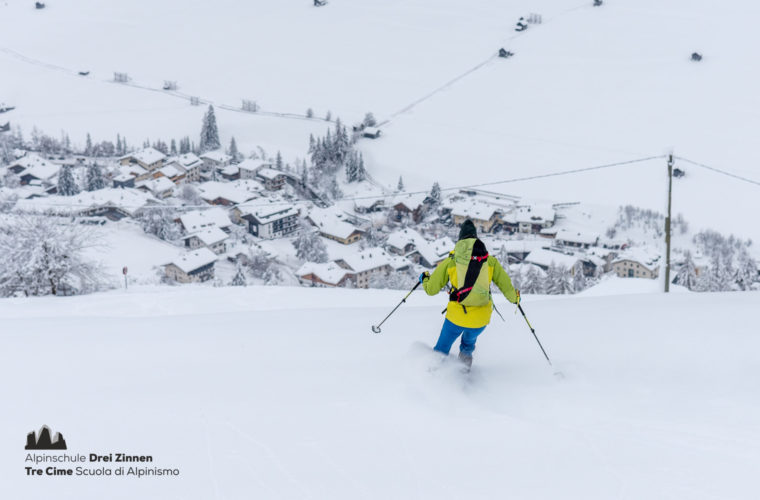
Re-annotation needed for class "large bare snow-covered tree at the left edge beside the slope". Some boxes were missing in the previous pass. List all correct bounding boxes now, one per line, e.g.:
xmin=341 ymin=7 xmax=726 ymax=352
xmin=0 ymin=217 xmax=104 ymax=297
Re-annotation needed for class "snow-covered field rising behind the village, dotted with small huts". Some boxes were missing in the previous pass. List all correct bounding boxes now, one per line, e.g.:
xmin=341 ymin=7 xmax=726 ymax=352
xmin=0 ymin=0 xmax=760 ymax=240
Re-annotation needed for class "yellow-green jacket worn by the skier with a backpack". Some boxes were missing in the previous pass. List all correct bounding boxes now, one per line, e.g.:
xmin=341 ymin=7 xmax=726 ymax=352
xmin=422 ymin=251 xmax=517 ymax=328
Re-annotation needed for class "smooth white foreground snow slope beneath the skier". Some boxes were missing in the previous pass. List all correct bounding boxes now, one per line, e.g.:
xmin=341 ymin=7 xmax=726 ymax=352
xmin=0 ymin=287 xmax=760 ymax=500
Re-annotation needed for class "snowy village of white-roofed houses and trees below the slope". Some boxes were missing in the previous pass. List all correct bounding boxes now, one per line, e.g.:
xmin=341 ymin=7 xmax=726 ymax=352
xmin=0 ymin=106 xmax=760 ymax=296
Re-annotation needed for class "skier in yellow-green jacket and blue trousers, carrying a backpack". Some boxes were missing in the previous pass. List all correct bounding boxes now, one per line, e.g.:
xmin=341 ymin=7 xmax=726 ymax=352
xmin=419 ymin=219 xmax=520 ymax=370
